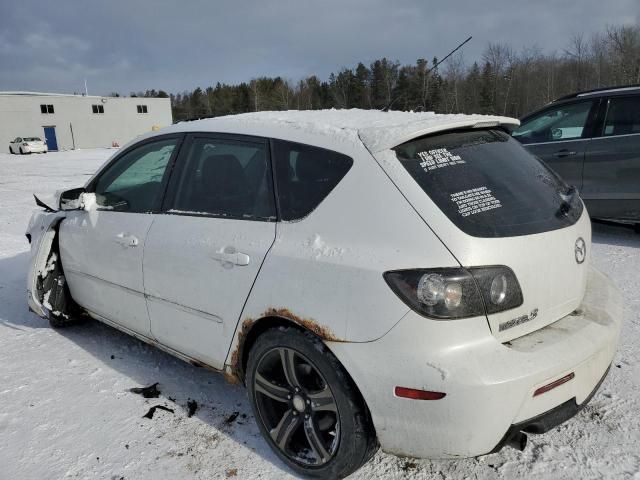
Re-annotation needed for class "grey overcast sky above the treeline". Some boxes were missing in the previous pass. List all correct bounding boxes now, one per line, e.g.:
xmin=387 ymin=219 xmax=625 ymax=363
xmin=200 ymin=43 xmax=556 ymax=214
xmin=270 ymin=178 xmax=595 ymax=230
xmin=0 ymin=0 xmax=640 ymax=95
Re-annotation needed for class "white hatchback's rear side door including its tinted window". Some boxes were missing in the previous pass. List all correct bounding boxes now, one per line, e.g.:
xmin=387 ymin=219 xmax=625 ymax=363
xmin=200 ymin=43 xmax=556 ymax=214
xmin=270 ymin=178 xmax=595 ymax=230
xmin=144 ymin=134 xmax=276 ymax=369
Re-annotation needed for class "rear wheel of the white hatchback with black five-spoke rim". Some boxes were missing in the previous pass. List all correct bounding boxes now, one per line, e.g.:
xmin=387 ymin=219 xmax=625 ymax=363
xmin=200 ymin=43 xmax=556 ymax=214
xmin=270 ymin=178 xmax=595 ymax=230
xmin=246 ymin=327 xmax=378 ymax=478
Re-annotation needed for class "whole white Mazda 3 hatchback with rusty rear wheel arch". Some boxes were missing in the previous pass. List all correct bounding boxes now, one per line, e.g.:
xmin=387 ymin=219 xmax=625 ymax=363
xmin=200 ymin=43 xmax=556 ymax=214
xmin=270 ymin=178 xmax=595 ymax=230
xmin=27 ymin=110 xmax=622 ymax=478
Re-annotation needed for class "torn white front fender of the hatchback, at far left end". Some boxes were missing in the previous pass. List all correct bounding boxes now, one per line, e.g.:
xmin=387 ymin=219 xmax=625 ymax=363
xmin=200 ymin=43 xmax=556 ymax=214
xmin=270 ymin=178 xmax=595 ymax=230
xmin=26 ymin=211 xmax=66 ymax=318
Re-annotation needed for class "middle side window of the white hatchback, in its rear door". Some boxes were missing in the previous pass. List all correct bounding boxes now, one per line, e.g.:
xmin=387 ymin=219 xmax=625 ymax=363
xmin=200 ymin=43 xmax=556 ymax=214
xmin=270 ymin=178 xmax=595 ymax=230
xmin=171 ymin=137 xmax=276 ymax=220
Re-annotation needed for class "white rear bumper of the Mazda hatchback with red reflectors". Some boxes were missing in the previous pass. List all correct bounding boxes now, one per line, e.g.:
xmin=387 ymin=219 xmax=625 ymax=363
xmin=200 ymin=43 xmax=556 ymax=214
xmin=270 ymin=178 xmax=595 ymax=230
xmin=328 ymin=269 xmax=622 ymax=458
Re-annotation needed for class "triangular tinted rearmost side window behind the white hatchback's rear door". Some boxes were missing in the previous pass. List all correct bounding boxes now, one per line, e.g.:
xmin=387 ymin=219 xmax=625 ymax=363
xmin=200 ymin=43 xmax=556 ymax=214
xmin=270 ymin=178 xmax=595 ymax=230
xmin=273 ymin=140 xmax=353 ymax=220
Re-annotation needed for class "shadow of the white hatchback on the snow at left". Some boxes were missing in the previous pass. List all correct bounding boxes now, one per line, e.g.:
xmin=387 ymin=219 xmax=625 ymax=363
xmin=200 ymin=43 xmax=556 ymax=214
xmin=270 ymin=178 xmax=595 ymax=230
xmin=0 ymin=252 xmax=293 ymax=475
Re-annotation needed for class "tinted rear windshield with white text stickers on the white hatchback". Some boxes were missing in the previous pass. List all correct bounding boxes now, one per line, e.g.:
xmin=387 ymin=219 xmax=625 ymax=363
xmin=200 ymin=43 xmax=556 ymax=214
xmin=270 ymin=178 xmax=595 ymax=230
xmin=394 ymin=129 xmax=583 ymax=237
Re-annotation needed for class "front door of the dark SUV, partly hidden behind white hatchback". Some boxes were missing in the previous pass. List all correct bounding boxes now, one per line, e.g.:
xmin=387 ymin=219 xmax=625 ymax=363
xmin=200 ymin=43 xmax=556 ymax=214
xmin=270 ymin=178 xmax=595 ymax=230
xmin=513 ymin=100 xmax=597 ymax=189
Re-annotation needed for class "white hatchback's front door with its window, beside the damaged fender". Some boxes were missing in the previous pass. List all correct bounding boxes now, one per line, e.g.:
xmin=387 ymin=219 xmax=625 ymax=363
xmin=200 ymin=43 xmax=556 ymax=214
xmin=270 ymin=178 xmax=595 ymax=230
xmin=59 ymin=136 xmax=182 ymax=336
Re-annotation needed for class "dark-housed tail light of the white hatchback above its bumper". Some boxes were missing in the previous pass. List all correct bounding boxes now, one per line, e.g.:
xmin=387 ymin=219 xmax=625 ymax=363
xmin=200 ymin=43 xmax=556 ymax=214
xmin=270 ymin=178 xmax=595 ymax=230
xmin=384 ymin=266 xmax=523 ymax=320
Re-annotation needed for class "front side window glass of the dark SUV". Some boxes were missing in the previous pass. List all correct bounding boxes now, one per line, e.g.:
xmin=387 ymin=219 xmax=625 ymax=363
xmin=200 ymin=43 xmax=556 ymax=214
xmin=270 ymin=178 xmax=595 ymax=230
xmin=513 ymin=101 xmax=593 ymax=144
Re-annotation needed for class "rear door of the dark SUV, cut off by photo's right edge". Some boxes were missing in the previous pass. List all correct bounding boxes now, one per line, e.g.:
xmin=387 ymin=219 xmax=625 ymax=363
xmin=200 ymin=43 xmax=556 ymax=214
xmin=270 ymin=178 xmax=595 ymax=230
xmin=582 ymin=95 xmax=640 ymax=222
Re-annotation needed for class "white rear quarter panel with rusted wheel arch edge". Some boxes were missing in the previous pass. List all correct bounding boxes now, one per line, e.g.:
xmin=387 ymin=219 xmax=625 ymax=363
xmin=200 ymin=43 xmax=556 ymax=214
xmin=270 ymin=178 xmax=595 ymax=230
xmin=227 ymin=141 xmax=458 ymax=363
